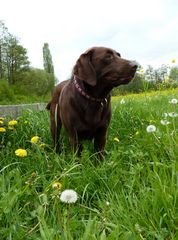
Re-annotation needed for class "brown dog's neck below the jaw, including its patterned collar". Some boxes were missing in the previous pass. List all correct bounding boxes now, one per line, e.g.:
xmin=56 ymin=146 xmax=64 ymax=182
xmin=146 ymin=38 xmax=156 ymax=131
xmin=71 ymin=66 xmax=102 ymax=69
xmin=73 ymin=76 xmax=111 ymax=103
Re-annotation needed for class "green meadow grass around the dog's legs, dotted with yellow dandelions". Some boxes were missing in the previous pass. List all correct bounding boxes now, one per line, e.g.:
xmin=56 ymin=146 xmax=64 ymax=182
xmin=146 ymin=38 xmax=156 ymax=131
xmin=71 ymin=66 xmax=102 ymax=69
xmin=0 ymin=90 xmax=178 ymax=240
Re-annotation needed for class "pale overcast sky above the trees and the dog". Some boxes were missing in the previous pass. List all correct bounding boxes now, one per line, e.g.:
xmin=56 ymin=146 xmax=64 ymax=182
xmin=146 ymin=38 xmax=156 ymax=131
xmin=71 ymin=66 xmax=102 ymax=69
xmin=0 ymin=0 xmax=178 ymax=82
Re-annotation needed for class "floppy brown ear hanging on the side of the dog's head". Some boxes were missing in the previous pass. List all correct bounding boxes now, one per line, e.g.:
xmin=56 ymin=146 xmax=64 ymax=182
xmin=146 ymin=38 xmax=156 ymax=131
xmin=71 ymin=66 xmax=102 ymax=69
xmin=73 ymin=51 xmax=97 ymax=86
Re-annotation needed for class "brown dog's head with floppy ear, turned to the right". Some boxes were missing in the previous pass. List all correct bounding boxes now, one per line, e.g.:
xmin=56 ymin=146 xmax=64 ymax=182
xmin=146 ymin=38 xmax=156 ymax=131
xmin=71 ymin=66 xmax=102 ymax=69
xmin=73 ymin=47 xmax=137 ymax=87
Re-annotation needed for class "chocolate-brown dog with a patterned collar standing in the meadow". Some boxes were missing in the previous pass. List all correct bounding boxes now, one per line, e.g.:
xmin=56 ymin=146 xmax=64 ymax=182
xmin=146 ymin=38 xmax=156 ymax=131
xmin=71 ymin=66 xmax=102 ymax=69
xmin=46 ymin=47 xmax=137 ymax=155
